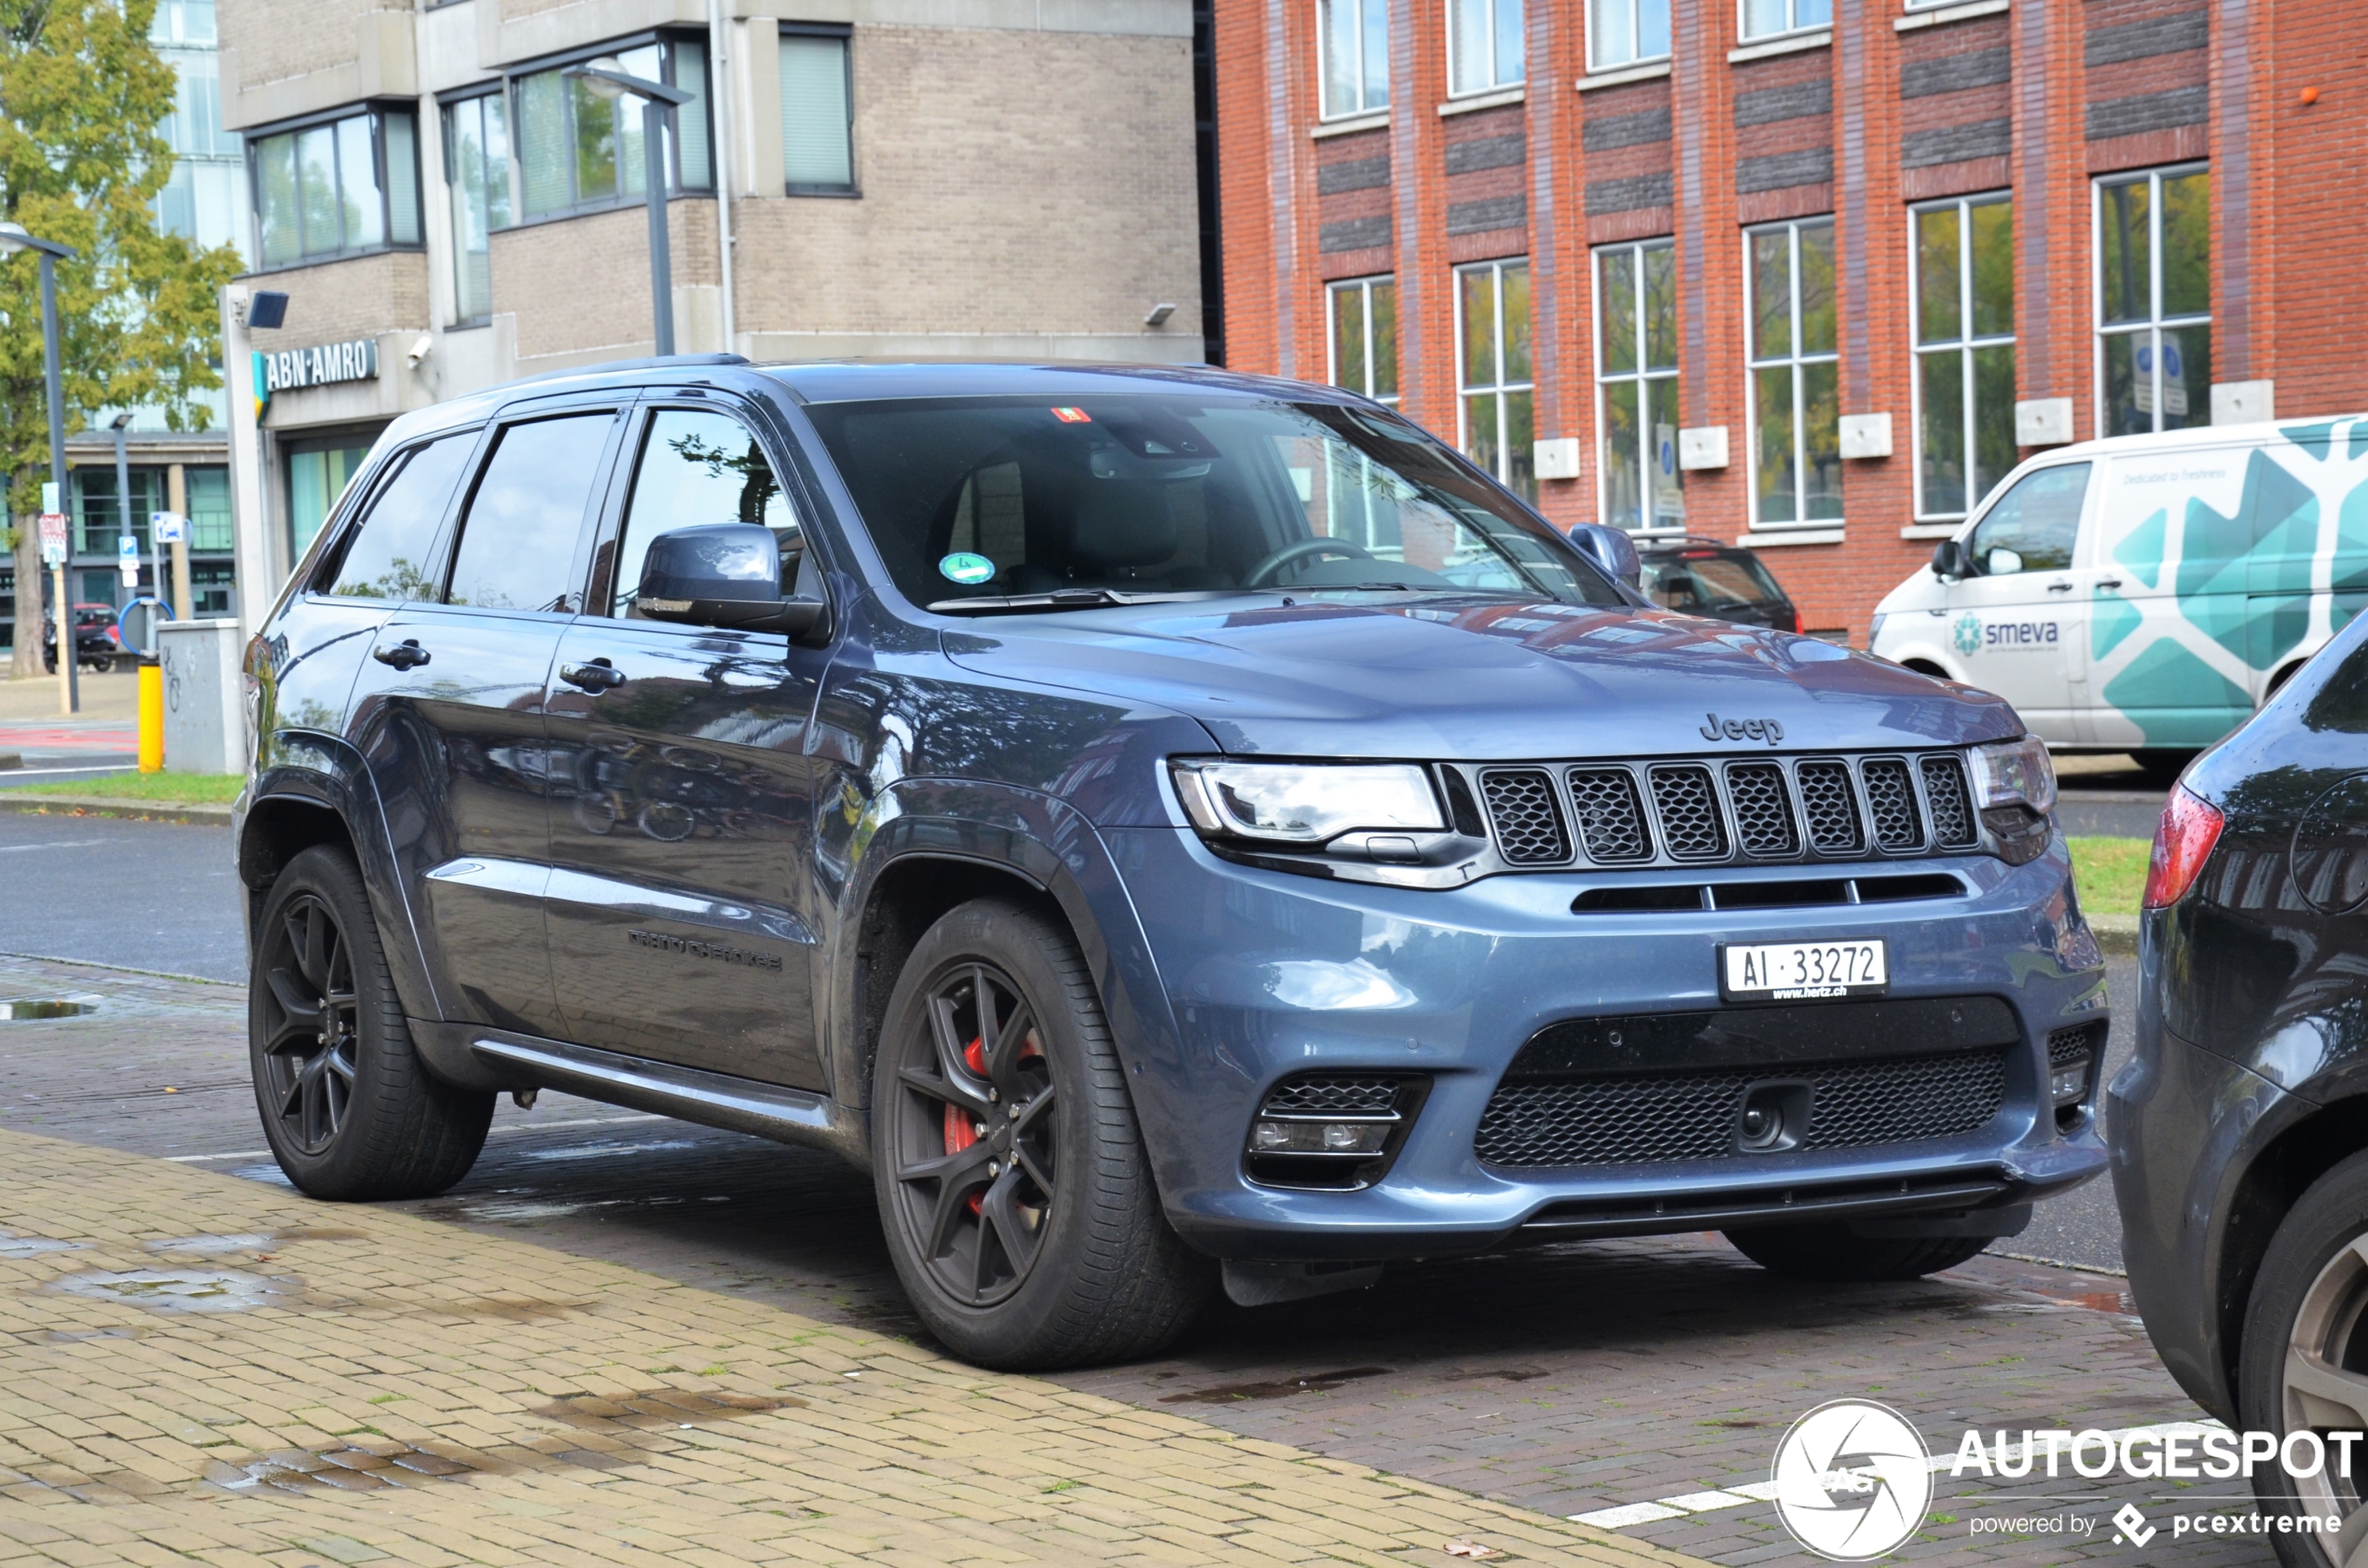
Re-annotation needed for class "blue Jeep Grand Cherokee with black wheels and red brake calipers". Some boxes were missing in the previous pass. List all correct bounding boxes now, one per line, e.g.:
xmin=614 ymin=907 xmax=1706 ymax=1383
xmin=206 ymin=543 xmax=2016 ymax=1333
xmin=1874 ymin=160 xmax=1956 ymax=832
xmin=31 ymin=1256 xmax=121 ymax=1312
xmin=237 ymin=358 xmax=2105 ymax=1367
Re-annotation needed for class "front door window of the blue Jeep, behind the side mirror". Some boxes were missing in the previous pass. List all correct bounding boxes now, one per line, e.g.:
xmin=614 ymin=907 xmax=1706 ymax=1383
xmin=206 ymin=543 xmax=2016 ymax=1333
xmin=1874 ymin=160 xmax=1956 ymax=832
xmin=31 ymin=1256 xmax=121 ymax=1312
xmin=609 ymin=407 xmax=805 ymax=616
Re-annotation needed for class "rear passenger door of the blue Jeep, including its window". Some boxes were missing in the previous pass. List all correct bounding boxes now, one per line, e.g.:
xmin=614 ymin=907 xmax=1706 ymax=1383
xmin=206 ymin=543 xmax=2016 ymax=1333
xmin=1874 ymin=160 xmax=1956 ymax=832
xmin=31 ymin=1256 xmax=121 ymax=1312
xmin=352 ymin=400 xmax=620 ymax=1035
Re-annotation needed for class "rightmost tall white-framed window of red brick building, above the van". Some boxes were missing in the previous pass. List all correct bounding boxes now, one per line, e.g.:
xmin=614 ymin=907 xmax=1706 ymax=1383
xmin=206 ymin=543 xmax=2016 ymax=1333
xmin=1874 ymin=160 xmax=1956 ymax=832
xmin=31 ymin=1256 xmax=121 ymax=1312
xmin=2096 ymin=168 xmax=2211 ymax=436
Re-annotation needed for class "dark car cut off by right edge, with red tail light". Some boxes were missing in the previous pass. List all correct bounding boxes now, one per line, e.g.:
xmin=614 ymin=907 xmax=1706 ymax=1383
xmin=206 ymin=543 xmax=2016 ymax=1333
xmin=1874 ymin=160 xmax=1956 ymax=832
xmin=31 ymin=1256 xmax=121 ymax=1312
xmin=2108 ymin=616 xmax=2368 ymax=1568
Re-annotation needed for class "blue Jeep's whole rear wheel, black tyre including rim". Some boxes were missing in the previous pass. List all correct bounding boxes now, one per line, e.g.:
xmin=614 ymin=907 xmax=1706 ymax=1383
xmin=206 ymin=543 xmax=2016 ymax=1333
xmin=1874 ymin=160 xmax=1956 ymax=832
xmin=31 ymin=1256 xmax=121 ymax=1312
xmin=246 ymin=844 xmax=492 ymax=1204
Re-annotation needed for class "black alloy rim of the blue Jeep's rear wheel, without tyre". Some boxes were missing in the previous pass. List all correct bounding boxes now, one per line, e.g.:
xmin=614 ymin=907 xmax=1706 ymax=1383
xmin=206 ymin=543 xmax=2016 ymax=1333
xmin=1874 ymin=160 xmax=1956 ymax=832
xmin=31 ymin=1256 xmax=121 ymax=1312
xmin=260 ymin=893 xmax=360 ymax=1156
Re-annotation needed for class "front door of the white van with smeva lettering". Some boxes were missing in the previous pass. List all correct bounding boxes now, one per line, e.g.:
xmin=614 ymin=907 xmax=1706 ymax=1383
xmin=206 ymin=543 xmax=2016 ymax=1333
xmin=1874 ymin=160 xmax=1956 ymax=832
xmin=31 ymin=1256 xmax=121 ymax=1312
xmin=1948 ymin=461 xmax=2091 ymax=744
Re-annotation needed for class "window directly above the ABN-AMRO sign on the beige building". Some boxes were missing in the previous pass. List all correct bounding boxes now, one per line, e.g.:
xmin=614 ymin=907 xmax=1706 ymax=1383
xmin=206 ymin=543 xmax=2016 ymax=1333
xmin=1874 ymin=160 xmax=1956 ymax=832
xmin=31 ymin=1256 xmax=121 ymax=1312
xmin=251 ymin=109 xmax=420 ymax=268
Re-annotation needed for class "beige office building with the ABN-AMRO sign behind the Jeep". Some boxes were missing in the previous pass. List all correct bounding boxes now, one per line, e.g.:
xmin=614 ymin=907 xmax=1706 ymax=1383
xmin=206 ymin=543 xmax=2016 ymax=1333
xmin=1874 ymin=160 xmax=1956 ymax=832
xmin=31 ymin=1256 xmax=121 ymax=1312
xmin=223 ymin=0 xmax=1205 ymax=601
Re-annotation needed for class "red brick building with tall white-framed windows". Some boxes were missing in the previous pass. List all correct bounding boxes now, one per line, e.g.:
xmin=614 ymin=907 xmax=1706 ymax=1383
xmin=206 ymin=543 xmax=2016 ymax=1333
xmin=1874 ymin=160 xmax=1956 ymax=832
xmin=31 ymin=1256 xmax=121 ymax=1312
xmin=1215 ymin=0 xmax=2368 ymax=642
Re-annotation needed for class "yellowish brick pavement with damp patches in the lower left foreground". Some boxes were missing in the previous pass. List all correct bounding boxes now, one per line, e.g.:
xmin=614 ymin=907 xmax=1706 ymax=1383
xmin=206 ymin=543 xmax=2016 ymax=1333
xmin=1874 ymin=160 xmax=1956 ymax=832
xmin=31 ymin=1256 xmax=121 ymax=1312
xmin=0 ymin=1132 xmax=1691 ymax=1568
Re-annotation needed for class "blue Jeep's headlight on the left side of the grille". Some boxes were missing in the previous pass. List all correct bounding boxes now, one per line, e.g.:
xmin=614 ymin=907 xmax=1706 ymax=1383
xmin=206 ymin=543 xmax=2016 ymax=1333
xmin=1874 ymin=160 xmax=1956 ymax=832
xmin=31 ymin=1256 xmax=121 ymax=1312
xmin=1170 ymin=763 xmax=1447 ymax=846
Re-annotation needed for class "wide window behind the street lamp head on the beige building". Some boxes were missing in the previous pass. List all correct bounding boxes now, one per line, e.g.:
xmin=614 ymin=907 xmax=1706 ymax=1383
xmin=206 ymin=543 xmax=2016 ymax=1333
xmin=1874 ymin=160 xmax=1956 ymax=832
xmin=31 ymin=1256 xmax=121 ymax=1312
xmin=514 ymin=38 xmax=715 ymax=218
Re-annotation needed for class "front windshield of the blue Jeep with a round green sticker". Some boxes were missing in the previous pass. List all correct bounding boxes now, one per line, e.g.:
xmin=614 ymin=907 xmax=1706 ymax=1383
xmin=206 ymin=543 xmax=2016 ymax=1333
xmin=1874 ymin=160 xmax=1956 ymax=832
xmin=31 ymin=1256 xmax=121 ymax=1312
xmin=807 ymin=391 xmax=1622 ymax=612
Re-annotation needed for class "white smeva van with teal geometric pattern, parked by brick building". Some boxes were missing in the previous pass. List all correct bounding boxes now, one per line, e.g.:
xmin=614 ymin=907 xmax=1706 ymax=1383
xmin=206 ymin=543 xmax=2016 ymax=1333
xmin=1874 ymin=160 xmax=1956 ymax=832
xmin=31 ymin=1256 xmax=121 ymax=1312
xmin=1868 ymin=415 xmax=2368 ymax=767
